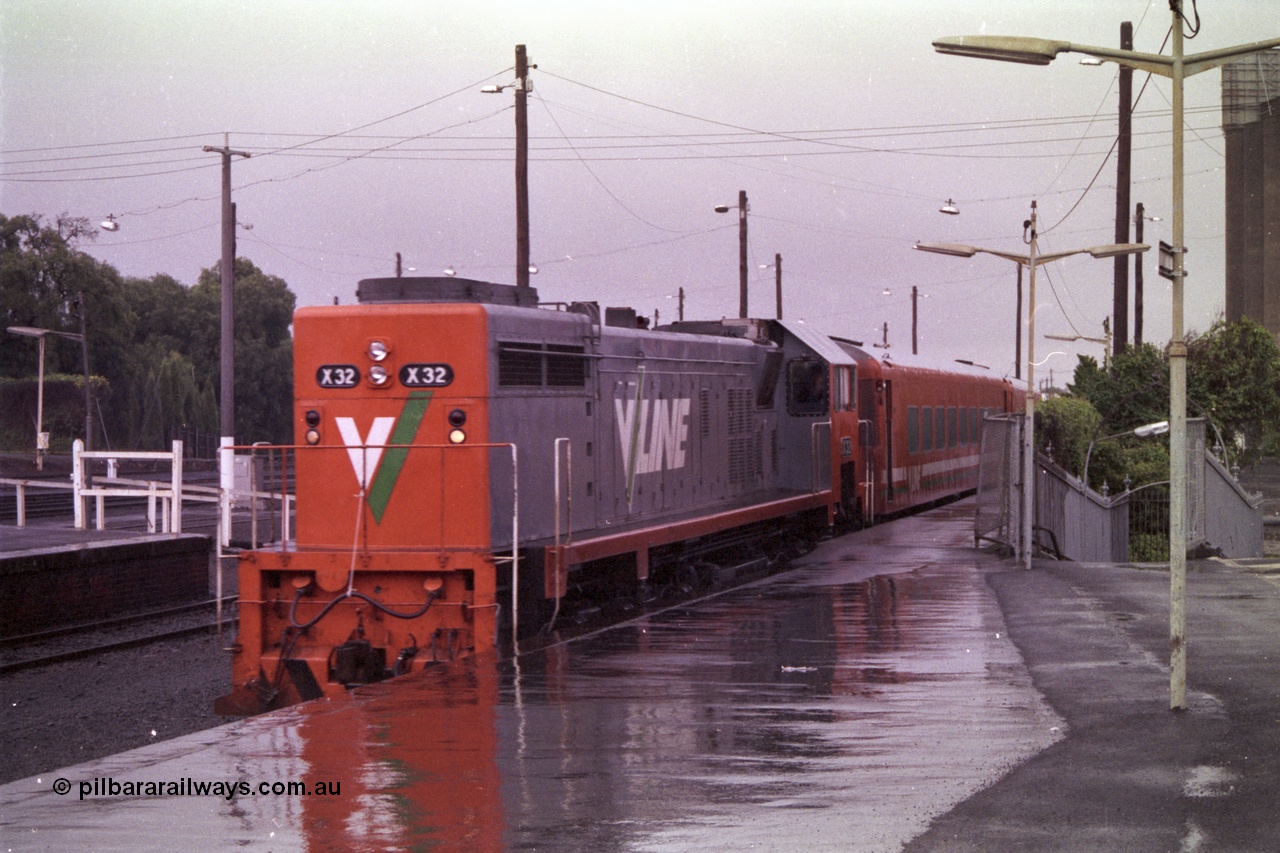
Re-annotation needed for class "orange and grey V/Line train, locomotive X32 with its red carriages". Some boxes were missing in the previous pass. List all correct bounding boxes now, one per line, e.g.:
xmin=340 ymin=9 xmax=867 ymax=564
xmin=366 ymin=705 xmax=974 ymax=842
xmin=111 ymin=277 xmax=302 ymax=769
xmin=216 ymin=278 xmax=1023 ymax=715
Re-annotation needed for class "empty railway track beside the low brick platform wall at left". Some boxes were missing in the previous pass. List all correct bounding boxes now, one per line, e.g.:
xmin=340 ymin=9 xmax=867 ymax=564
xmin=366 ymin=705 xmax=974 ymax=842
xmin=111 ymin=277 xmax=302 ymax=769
xmin=0 ymin=598 xmax=236 ymax=675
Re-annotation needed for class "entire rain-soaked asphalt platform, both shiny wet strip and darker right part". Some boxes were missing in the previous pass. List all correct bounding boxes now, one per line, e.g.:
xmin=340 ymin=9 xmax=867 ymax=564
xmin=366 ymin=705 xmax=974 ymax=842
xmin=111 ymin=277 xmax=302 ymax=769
xmin=0 ymin=503 xmax=1280 ymax=853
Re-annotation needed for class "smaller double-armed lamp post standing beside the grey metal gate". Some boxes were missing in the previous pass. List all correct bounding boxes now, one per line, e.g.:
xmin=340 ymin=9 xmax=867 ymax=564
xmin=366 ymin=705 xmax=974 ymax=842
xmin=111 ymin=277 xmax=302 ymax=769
xmin=915 ymin=201 xmax=1151 ymax=569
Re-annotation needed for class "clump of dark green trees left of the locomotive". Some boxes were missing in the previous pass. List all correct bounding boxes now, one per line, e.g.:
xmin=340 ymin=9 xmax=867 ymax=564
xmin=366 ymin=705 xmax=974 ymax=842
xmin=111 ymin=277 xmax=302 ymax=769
xmin=0 ymin=214 xmax=294 ymax=450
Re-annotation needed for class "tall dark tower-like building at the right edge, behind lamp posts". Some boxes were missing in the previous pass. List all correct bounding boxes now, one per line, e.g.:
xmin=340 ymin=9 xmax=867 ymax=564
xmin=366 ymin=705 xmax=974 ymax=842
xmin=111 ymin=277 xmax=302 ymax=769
xmin=1222 ymin=50 xmax=1280 ymax=341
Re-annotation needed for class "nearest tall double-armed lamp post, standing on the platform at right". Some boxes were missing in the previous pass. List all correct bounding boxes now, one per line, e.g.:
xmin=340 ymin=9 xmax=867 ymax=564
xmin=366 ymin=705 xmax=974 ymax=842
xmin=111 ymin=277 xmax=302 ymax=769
xmin=933 ymin=0 xmax=1280 ymax=711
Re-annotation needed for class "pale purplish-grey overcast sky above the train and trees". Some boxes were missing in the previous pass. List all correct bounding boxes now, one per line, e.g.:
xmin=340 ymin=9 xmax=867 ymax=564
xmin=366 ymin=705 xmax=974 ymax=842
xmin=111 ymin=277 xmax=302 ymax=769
xmin=0 ymin=0 xmax=1280 ymax=378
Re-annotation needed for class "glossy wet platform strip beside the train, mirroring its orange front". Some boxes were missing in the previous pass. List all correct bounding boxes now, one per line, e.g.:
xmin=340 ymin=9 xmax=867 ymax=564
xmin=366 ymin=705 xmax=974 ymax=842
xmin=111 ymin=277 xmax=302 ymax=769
xmin=0 ymin=502 xmax=1061 ymax=850
